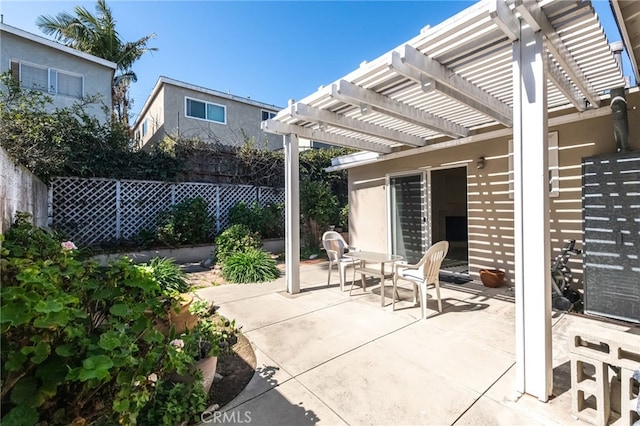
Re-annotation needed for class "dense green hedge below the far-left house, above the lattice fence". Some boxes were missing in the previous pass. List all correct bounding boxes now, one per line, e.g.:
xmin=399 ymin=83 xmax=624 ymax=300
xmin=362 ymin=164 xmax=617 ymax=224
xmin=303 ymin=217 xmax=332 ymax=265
xmin=0 ymin=72 xmax=183 ymax=183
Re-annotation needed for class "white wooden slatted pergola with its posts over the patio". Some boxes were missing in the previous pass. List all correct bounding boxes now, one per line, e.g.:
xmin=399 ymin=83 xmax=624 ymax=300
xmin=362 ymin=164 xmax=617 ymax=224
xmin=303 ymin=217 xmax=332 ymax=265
xmin=262 ymin=0 xmax=624 ymax=401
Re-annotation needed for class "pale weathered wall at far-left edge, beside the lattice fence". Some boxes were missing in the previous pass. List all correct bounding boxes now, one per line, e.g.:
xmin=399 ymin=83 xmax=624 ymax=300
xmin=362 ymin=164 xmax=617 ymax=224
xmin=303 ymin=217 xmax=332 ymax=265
xmin=0 ymin=147 xmax=48 ymax=233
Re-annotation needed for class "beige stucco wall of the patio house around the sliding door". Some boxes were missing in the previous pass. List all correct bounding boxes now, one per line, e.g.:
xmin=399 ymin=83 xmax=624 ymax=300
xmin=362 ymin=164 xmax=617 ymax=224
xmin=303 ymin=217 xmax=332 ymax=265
xmin=349 ymin=93 xmax=640 ymax=282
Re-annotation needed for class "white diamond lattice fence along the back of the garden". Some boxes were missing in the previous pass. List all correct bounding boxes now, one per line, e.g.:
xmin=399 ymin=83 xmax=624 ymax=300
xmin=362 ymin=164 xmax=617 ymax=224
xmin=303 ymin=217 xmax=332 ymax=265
xmin=49 ymin=178 xmax=284 ymax=245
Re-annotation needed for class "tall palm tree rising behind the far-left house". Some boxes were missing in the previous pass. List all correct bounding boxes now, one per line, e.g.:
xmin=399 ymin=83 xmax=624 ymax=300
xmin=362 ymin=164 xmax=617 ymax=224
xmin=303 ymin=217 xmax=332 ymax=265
xmin=36 ymin=0 xmax=158 ymax=127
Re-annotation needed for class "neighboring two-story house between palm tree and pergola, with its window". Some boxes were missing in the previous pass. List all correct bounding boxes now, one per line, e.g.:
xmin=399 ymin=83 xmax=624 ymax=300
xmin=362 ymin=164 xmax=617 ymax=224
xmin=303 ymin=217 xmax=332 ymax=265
xmin=133 ymin=77 xmax=282 ymax=150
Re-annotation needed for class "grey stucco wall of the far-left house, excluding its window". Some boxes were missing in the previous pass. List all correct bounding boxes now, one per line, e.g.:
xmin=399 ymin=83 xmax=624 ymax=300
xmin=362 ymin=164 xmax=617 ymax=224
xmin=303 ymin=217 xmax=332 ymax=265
xmin=0 ymin=31 xmax=113 ymax=123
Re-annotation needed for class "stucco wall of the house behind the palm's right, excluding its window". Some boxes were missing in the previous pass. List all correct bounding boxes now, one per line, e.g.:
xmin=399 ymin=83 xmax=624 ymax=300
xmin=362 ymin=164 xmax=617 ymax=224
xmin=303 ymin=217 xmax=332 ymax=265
xmin=134 ymin=84 xmax=282 ymax=150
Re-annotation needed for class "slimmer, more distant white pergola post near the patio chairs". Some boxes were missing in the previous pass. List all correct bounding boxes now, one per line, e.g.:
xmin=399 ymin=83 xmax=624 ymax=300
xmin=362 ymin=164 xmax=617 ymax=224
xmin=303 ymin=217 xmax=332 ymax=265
xmin=283 ymin=134 xmax=300 ymax=294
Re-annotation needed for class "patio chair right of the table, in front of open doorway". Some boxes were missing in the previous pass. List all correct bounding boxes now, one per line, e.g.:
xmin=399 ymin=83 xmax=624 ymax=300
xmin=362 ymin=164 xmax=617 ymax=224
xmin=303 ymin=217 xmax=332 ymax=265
xmin=393 ymin=241 xmax=449 ymax=319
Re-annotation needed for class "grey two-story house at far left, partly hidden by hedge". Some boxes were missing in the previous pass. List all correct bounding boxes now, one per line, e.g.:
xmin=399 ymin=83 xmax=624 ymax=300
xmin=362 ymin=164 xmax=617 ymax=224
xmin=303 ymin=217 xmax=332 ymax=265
xmin=0 ymin=23 xmax=116 ymax=123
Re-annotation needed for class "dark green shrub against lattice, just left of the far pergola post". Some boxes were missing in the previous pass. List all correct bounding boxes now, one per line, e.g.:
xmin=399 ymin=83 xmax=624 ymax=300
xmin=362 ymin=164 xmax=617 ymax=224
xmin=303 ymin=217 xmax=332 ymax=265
xmin=229 ymin=201 xmax=284 ymax=238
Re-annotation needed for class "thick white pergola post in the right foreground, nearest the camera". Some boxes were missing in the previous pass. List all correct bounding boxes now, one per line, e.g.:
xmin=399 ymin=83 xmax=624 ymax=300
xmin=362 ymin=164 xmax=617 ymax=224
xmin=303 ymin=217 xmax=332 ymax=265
xmin=513 ymin=24 xmax=553 ymax=402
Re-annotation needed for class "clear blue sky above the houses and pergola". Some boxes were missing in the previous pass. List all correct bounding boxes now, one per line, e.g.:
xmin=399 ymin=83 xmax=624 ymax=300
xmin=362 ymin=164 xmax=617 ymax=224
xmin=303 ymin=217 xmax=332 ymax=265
xmin=0 ymin=0 xmax=631 ymax=123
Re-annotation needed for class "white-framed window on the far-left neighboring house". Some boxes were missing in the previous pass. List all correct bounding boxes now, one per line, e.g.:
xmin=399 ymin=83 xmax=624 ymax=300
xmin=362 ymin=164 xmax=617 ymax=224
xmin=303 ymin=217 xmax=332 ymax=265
xmin=11 ymin=61 xmax=83 ymax=98
